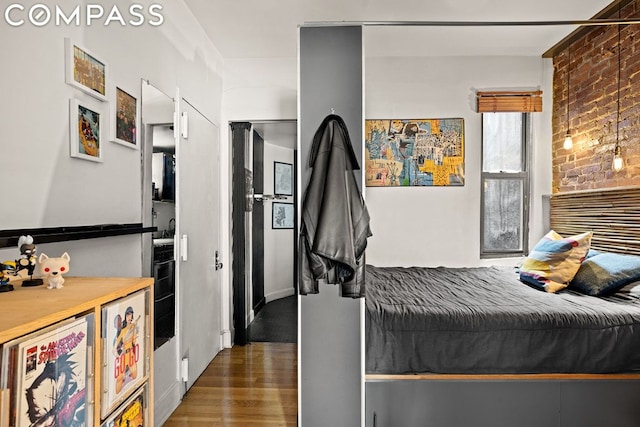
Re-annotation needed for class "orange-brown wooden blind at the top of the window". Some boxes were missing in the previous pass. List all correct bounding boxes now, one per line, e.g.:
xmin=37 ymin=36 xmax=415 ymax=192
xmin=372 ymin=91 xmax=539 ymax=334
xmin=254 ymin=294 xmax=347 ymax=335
xmin=476 ymin=90 xmax=542 ymax=113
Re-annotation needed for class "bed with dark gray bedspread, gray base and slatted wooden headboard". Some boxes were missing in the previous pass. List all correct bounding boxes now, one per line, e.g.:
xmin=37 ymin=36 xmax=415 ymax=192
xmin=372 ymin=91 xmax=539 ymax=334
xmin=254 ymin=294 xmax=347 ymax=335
xmin=364 ymin=187 xmax=640 ymax=427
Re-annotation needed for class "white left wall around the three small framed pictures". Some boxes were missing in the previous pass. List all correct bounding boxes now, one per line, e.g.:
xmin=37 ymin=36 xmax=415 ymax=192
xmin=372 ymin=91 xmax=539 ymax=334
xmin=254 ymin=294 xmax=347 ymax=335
xmin=0 ymin=0 xmax=228 ymax=424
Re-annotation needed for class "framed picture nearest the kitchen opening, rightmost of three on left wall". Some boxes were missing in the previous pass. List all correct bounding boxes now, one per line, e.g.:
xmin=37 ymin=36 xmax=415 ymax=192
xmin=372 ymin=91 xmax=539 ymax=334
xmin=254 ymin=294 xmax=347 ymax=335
xmin=111 ymin=86 xmax=140 ymax=149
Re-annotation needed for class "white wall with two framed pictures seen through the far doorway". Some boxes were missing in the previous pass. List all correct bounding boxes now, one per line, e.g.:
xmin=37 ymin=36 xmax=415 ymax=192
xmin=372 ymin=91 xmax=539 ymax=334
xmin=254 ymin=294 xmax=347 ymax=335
xmin=264 ymin=141 xmax=295 ymax=303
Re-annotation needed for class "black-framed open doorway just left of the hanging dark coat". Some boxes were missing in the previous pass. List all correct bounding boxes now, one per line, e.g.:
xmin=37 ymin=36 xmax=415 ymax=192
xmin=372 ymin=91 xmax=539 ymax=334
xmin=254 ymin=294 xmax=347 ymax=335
xmin=230 ymin=120 xmax=297 ymax=345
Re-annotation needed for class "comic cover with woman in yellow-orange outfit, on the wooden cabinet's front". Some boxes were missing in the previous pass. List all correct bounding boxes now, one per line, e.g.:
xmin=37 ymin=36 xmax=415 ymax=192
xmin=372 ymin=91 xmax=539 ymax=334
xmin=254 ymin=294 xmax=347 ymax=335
xmin=101 ymin=291 xmax=147 ymax=418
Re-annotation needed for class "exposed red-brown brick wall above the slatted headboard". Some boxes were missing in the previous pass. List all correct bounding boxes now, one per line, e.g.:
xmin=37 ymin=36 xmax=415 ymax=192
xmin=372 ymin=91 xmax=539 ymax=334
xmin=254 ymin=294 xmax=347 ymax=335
xmin=552 ymin=0 xmax=640 ymax=193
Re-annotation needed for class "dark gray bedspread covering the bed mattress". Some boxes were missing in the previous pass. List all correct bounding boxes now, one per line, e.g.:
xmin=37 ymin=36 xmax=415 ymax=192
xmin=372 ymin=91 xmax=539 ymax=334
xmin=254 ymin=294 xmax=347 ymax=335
xmin=365 ymin=266 xmax=640 ymax=374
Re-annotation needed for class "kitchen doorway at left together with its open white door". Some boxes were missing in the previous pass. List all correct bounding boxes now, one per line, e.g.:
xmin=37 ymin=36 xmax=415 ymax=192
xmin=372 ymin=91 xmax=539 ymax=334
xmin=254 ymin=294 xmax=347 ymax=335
xmin=141 ymin=81 xmax=222 ymax=423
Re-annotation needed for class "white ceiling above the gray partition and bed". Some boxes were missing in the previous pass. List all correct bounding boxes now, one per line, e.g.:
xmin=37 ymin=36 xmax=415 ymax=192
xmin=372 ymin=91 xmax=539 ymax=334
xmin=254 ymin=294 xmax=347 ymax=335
xmin=185 ymin=0 xmax=611 ymax=59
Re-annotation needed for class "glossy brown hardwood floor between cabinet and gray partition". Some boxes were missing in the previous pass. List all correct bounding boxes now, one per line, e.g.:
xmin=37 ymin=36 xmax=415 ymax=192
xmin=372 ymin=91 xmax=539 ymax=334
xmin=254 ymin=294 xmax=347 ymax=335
xmin=164 ymin=342 xmax=298 ymax=427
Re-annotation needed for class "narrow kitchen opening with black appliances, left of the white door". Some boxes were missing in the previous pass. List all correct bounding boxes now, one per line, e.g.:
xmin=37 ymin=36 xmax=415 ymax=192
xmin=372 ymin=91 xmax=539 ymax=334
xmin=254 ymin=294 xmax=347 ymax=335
xmin=141 ymin=80 xmax=181 ymax=420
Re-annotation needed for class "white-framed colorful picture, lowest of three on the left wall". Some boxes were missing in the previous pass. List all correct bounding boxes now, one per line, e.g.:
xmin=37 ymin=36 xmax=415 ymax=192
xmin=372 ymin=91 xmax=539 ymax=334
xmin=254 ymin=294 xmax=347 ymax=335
xmin=69 ymin=98 xmax=107 ymax=162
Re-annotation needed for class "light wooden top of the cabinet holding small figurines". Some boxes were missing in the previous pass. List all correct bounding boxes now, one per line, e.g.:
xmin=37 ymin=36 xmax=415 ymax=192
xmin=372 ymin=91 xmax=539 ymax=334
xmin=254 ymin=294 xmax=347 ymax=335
xmin=0 ymin=276 xmax=153 ymax=343
